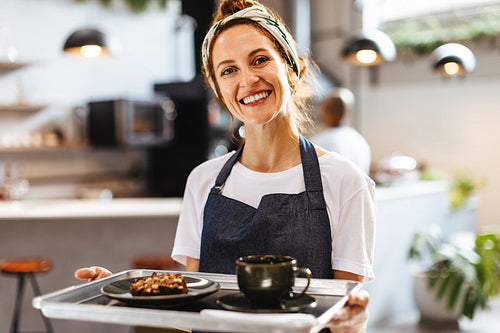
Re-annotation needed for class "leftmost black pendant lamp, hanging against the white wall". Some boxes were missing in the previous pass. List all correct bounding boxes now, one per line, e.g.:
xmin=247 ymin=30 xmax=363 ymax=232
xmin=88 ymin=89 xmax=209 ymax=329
xmin=64 ymin=29 xmax=110 ymax=59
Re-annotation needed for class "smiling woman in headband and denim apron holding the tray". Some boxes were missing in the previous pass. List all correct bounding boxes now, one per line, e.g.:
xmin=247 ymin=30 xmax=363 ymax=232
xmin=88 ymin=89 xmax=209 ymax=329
xmin=76 ymin=0 xmax=374 ymax=332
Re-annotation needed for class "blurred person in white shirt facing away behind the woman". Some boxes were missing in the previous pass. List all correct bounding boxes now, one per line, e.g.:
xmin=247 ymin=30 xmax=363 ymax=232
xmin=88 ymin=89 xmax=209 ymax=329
xmin=311 ymin=88 xmax=371 ymax=174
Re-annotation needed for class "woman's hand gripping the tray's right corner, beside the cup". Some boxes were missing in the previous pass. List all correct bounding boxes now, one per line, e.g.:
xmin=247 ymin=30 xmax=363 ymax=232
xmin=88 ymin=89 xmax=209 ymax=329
xmin=327 ymin=290 xmax=370 ymax=333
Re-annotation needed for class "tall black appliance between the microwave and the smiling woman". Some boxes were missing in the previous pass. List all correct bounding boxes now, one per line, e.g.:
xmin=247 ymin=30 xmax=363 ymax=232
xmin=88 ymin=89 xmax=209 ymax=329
xmin=148 ymin=77 xmax=237 ymax=197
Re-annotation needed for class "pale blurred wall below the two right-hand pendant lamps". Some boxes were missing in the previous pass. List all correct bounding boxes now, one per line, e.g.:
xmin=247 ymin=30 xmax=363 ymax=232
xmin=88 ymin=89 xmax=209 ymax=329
xmin=360 ymin=49 xmax=500 ymax=226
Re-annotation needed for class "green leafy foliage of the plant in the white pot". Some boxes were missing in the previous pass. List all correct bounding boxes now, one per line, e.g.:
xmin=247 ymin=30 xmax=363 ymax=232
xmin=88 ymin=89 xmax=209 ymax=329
xmin=408 ymin=228 xmax=500 ymax=319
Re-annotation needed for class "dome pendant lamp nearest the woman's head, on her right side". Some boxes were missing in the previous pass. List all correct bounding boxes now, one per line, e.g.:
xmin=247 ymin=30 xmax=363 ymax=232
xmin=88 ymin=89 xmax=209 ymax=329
xmin=342 ymin=30 xmax=396 ymax=66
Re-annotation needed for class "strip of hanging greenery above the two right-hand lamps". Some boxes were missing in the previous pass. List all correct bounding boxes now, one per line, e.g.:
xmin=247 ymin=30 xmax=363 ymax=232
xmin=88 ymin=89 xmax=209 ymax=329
xmin=383 ymin=9 xmax=500 ymax=56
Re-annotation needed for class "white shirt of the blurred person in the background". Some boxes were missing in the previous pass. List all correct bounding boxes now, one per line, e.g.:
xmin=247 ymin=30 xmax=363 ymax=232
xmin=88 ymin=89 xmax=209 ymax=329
xmin=311 ymin=125 xmax=371 ymax=174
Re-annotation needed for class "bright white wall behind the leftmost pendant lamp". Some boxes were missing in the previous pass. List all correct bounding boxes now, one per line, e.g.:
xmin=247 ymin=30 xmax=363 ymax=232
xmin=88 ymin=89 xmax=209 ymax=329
xmin=0 ymin=0 xmax=188 ymax=136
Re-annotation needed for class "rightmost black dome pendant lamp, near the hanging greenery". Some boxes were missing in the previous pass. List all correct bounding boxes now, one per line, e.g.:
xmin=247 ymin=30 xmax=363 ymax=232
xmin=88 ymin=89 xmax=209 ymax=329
xmin=431 ymin=43 xmax=476 ymax=76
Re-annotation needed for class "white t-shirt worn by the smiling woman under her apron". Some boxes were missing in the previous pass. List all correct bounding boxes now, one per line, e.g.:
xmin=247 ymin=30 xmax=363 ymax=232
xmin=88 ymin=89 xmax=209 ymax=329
xmin=172 ymin=152 xmax=375 ymax=281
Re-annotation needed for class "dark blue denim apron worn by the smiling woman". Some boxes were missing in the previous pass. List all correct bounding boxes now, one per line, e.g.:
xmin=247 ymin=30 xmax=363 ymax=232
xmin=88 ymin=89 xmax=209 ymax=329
xmin=199 ymin=135 xmax=333 ymax=278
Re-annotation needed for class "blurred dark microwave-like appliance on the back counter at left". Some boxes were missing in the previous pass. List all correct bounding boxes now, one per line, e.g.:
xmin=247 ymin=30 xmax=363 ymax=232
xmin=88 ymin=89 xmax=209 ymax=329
xmin=86 ymin=98 xmax=176 ymax=147
